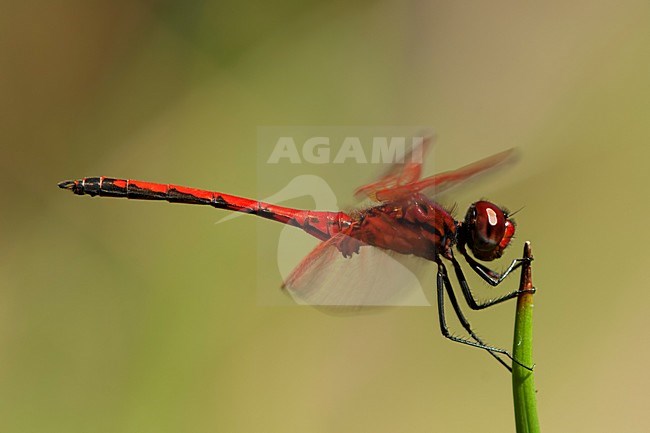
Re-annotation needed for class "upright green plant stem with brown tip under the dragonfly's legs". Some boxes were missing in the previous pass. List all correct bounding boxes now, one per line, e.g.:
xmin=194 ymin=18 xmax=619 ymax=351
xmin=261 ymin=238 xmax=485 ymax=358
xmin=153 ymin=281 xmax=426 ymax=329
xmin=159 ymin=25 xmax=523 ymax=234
xmin=512 ymin=242 xmax=540 ymax=433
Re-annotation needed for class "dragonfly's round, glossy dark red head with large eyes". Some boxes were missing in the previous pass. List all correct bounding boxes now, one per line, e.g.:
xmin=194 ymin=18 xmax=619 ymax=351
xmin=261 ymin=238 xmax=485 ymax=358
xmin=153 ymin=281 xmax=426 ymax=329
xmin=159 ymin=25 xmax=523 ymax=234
xmin=463 ymin=200 xmax=515 ymax=261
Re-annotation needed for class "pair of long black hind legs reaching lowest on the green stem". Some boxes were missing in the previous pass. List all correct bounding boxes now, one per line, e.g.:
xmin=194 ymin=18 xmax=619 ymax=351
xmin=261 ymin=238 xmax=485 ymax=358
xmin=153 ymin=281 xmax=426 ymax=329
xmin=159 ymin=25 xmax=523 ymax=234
xmin=436 ymin=260 xmax=530 ymax=371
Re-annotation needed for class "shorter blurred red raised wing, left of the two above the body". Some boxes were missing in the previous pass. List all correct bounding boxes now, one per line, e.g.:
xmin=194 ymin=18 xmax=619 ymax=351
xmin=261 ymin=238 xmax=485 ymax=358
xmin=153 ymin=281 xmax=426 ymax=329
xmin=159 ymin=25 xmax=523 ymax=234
xmin=354 ymin=136 xmax=435 ymax=200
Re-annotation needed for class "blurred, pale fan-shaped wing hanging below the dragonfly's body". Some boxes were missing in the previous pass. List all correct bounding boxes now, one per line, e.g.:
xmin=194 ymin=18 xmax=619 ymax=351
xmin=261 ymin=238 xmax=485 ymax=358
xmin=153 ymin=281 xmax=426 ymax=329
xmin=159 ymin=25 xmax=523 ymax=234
xmin=282 ymin=233 xmax=430 ymax=307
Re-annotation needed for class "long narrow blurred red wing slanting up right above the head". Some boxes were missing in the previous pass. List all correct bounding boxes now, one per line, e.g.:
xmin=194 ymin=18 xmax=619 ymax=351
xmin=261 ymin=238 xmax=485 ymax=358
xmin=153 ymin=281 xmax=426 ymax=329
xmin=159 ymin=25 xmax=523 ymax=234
xmin=375 ymin=148 xmax=517 ymax=201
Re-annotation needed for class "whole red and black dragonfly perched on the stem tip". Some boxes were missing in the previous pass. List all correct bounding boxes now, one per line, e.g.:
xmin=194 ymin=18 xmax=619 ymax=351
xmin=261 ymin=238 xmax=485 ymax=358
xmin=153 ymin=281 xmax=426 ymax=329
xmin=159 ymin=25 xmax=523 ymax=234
xmin=59 ymin=138 xmax=534 ymax=371
